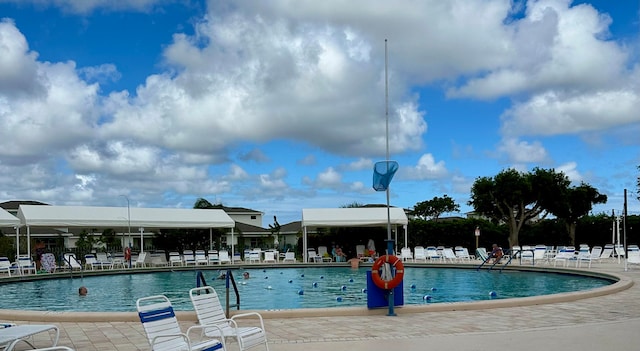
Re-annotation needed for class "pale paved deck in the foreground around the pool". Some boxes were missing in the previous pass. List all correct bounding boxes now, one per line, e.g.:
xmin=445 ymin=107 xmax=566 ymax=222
xmin=3 ymin=263 xmax=640 ymax=351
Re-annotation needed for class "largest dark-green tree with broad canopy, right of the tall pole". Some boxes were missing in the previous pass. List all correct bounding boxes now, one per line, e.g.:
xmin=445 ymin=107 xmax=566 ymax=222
xmin=469 ymin=168 xmax=570 ymax=246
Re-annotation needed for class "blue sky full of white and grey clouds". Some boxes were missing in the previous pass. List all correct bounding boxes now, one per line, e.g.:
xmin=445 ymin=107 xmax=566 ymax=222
xmin=0 ymin=0 xmax=640 ymax=226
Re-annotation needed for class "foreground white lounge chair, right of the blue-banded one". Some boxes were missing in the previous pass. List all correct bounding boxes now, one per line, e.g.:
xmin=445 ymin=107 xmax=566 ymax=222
xmin=189 ymin=286 xmax=269 ymax=351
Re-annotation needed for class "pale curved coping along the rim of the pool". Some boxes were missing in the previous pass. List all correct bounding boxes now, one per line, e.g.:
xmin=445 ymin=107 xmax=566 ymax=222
xmin=0 ymin=263 xmax=634 ymax=322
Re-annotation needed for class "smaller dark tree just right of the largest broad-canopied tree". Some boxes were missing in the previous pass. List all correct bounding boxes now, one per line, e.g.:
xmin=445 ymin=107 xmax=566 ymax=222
xmin=546 ymin=183 xmax=607 ymax=245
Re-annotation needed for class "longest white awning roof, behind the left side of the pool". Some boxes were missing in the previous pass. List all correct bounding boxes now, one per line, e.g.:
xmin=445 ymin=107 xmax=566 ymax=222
xmin=14 ymin=205 xmax=235 ymax=228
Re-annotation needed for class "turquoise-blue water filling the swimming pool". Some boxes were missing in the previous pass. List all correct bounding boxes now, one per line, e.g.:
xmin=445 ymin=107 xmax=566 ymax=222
xmin=0 ymin=267 xmax=612 ymax=312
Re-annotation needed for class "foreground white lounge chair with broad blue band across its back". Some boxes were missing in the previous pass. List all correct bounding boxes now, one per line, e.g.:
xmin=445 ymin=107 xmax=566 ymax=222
xmin=136 ymin=295 xmax=226 ymax=351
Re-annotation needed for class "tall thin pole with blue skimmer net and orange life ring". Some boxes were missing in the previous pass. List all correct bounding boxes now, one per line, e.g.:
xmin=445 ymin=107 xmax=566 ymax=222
xmin=367 ymin=39 xmax=404 ymax=316
